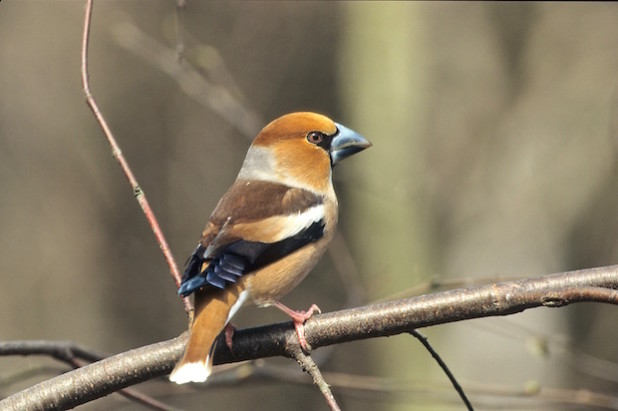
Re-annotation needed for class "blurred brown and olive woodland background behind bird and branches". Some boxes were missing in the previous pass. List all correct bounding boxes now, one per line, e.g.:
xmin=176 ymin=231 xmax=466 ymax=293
xmin=0 ymin=0 xmax=618 ymax=410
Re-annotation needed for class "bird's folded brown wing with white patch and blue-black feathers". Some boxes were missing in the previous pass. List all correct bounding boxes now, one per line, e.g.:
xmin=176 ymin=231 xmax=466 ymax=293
xmin=178 ymin=180 xmax=324 ymax=296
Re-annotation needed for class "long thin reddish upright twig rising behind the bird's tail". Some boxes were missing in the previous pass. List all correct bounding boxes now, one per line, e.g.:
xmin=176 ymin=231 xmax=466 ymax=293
xmin=81 ymin=0 xmax=193 ymax=313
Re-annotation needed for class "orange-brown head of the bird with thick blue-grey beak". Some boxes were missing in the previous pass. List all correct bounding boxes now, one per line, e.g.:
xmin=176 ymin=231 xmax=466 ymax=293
xmin=238 ymin=112 xmax=371 ymax=191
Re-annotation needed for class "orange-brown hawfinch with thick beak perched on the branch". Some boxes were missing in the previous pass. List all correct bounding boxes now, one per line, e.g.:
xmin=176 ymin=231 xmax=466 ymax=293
xmin=169 ymin=112 xmax=371 ymax=384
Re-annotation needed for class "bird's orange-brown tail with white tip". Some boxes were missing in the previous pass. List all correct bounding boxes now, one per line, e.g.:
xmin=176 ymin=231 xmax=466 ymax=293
xmin=170 ymin=286 xmax=240 ymax=384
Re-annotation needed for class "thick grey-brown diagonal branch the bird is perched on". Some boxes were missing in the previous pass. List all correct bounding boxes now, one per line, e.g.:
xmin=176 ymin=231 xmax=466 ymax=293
xmin=0 ymin=265 xmax=618 ymax=411
